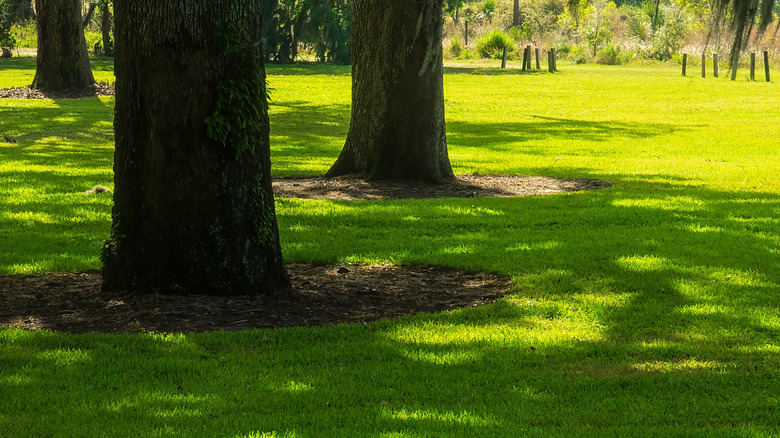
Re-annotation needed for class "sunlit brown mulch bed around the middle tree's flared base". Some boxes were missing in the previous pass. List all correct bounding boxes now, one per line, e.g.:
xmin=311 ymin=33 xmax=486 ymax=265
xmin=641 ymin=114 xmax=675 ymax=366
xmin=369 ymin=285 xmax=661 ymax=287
xmin=273 ymin=175 xmax=612 ymax=201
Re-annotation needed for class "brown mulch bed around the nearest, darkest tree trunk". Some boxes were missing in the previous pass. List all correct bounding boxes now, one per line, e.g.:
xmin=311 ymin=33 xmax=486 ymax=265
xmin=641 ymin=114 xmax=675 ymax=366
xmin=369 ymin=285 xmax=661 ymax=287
xmin=0 ymin=263 xmax=511 ymax=333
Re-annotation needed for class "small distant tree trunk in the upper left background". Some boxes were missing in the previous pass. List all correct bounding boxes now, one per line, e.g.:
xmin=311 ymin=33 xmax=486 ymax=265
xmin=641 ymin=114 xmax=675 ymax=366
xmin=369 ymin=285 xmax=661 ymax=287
xmin=32 ymin=0 xmax=95 ymax=91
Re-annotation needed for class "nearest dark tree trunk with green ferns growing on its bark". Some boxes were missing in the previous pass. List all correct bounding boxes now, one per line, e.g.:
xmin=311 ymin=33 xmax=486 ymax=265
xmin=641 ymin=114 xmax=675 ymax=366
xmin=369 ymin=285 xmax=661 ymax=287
xmin=103 ymin=0 xmax=289 ymax=294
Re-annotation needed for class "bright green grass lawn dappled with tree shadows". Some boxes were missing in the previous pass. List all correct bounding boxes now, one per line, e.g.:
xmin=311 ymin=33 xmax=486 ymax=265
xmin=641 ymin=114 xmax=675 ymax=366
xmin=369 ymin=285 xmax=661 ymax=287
xmin=0 ymin=60 xmax=780 ymax=437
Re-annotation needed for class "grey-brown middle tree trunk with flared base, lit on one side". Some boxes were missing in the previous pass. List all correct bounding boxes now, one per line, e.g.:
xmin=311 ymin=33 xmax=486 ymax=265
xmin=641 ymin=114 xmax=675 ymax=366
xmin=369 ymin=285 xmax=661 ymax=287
xmin=327 ymin=0 xmax=453 ymax=182
